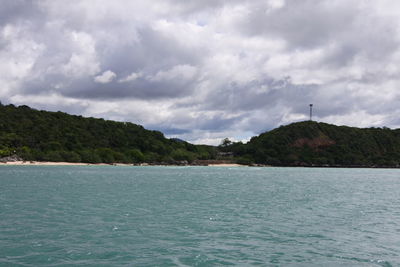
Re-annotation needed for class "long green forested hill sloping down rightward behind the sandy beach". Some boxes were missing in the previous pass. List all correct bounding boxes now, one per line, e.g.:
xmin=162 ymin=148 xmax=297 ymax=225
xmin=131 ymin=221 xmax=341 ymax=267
xmin=0 ymin=104 xmax=215 ymax=164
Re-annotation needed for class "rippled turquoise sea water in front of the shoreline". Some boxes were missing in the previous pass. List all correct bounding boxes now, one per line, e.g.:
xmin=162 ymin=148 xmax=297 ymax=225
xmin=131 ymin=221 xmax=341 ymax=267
xmin=0 ymin=166 xmax=400 ymax=266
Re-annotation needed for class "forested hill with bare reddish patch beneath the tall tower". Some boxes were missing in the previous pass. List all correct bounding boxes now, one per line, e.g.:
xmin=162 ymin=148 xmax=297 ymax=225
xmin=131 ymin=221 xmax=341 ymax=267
xmin=221 ymin=121 xmax=400 ymax=167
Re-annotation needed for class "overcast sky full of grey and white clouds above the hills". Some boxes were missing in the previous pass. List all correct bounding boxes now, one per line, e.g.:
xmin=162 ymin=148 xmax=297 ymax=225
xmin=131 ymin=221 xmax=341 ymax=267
xmin=0 ymin=0 xmax=400 ymax=145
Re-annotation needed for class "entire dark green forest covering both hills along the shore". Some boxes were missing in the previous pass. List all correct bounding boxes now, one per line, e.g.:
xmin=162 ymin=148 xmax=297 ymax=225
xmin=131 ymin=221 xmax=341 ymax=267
xmin=0 ymin=104 xmax=400 ymax=167
